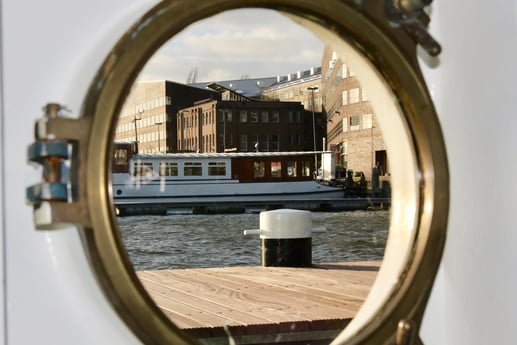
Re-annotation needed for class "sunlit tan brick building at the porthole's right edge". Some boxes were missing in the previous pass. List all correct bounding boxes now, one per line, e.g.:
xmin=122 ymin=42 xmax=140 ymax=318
xmin=321 ymin=46 xmax=389 ymax=179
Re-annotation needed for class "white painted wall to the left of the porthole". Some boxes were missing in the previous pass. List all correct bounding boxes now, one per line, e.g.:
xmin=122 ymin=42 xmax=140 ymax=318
xmin=0 ymin=0 xmax=156 ymax=344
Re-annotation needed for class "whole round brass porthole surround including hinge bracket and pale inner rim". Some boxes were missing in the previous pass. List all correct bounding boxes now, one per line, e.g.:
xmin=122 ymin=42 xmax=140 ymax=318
xmin=28 ymin=0 xmax=449 ymax=344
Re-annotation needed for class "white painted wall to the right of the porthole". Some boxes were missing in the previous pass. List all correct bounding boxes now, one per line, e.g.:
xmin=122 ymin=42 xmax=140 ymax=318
xmin=422 ymin=0 xmax=517 ymax=345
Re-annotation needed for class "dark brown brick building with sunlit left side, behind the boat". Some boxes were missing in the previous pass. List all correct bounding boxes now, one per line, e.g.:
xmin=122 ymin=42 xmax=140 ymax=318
xmin=177 ymin=95 xmax=314 ymax=152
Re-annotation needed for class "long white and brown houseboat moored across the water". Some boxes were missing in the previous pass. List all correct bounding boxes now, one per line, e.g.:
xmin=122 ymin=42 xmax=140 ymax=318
xmin=112 ymin=142 xmax=344 ymax=207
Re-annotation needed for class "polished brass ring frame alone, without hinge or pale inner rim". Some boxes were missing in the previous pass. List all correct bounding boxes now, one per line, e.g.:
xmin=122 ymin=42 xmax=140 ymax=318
xmin=70 ymin=0 xmax=449 ymax=345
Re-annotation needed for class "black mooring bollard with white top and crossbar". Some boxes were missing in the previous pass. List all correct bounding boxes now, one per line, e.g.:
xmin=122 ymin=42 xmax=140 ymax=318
xmin=244 ymin=209 xmax=325 ymax=267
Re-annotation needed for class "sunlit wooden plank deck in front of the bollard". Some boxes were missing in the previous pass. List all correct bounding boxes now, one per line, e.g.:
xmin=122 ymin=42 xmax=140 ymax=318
xmin=137 ymin=261 xmax=380 ymax=344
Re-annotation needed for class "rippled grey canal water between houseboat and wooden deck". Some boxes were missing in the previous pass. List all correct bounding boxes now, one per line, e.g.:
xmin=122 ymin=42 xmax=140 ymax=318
xmin=118 ymin=210 xmax=390 ymax=271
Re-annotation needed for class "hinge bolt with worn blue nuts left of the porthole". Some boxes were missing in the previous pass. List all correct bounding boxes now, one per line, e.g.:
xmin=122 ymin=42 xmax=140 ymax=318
xmin=26 ymin=103 xmax=71 ymax=212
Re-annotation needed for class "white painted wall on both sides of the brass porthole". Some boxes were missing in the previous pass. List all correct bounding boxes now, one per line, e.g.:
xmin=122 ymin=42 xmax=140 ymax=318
xmin=0 ymin=0 xmax=517 ymax=345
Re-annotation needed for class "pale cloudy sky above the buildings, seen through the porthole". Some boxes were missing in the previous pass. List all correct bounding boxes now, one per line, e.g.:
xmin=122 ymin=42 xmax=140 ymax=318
xmin=138 ymin=9 xmax=324 ymax=83
